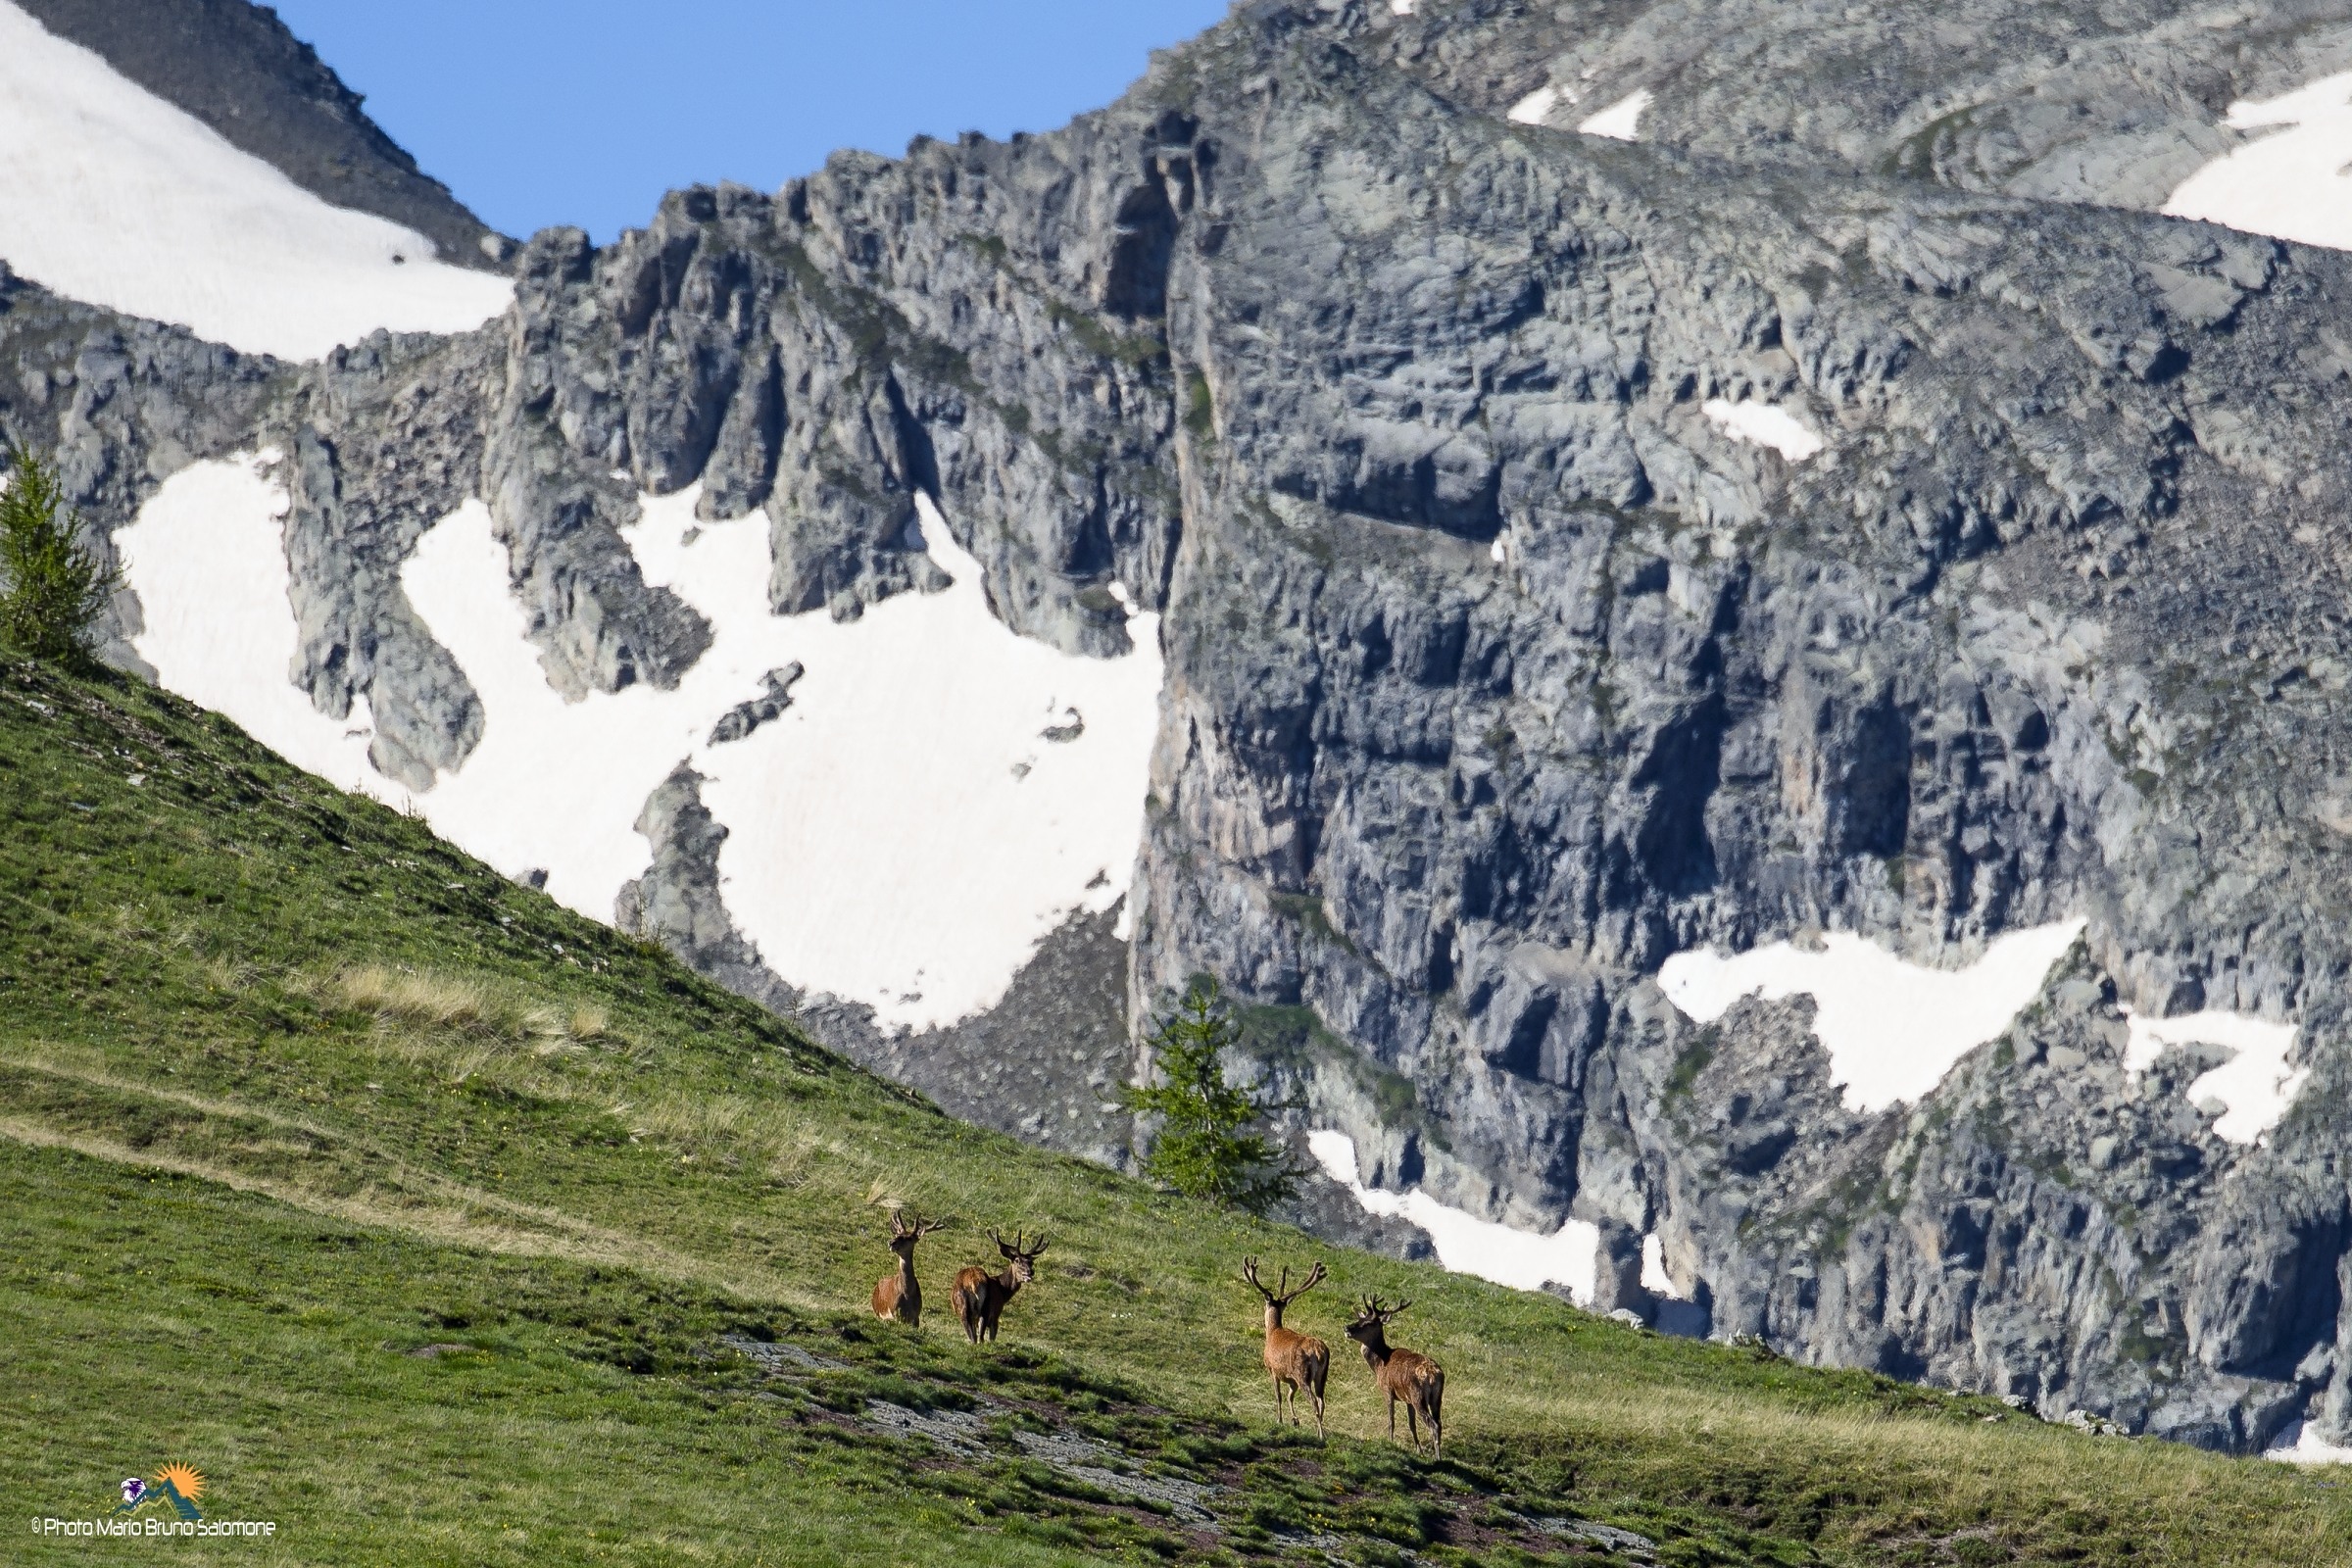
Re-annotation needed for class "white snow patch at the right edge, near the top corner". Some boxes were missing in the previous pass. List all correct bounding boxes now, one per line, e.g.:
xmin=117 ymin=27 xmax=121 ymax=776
xmin=2164 ymin=71 xmax=2352 ymax=249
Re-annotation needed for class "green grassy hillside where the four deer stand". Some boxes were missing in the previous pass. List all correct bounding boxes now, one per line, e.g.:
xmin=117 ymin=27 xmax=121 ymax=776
xmin=0 ymin=662 xmax=2352 ymax=1563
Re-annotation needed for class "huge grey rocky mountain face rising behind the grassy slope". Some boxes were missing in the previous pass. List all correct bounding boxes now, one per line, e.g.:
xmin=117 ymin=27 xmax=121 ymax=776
xmin=14 ymin=0 xmax=2352 ymax=1448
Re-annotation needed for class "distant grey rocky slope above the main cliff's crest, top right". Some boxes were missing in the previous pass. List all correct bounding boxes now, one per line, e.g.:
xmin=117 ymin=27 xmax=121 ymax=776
xmin=1369 ymin=0 xmax=2352 ymax=212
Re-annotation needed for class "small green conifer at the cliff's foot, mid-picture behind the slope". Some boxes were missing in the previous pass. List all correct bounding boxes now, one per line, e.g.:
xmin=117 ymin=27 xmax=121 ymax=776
xmin=1122 ymin=978 xmax=1298 ymax=1215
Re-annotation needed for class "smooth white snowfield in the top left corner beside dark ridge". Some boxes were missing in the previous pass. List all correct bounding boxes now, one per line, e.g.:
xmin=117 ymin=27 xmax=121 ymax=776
xmin=0 ymin=0 xmax=513 ymax=360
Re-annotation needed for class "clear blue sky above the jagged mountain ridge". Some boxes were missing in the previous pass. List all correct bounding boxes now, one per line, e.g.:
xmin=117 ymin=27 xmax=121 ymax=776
xmin=270 ymin=0 xmax=1225 ymax=242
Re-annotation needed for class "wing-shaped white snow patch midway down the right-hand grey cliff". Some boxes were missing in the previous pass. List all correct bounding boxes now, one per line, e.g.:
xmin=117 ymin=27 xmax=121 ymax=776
xmin=1658 ymin=919 xmax=2083 ymax=1114
